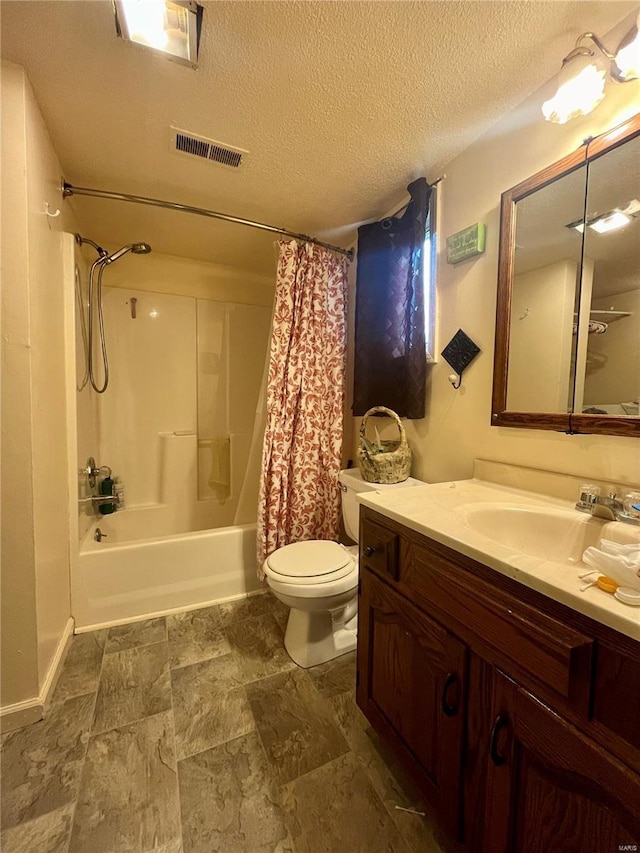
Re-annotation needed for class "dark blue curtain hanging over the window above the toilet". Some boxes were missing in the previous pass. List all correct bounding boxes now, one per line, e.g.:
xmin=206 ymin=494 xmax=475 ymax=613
xmin=353 ymin=178 xmax=432 ymax=418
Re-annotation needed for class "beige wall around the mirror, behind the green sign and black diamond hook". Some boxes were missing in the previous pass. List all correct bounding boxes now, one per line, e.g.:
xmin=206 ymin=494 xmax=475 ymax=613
xmin=351 ymin=45 xmax=640 ymax=483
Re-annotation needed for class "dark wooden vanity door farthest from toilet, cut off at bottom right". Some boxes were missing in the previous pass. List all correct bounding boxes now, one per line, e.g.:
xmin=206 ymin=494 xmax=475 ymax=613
xmin=482 ymin=672 xmax=640 ymax=853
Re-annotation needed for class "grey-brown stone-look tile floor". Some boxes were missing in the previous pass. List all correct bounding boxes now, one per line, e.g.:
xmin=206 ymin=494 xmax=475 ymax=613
xmin=0 ymin=594 xmax=440 ymax=853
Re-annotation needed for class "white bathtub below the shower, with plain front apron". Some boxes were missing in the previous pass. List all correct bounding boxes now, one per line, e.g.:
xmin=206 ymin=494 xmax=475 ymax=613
xmin=71 ymin=509 xmax=263 ymax=631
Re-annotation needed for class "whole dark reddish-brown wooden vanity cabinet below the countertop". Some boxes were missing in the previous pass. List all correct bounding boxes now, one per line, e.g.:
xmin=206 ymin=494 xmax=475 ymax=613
xmin=356 ymin=507 xmax=640 ymax=853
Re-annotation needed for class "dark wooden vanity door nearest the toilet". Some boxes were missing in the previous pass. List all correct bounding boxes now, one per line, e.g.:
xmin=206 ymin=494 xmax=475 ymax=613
xmin=357 ymin=570 xmax=466 ymax=836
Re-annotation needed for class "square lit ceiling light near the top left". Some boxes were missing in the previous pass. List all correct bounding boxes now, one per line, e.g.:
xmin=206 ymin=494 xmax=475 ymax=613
xmin=113 ymin=0 xmax=202 ymax=68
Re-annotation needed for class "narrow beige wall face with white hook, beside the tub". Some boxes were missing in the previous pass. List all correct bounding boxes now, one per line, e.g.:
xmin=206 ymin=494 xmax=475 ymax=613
xmin=25 ymin=65 xmax=71 ymax=689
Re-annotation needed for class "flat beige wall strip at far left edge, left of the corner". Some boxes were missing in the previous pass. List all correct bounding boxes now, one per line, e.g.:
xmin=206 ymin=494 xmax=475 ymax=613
xmin=0 ymin=65 xmax=38 ymax=720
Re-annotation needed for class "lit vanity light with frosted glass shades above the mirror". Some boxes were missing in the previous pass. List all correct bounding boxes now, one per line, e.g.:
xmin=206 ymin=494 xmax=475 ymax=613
xmin=542 ymin=13 xmax=640 ymax=124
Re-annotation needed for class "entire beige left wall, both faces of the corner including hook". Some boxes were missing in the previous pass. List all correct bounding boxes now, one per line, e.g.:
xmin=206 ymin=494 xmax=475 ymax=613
xmin=1 ymin=63 xmax=70 ymax=724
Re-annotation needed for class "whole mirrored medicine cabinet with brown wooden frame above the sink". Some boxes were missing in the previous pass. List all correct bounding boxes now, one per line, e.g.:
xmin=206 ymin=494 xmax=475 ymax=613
xmin=491 ymin=114 xmax=640 ymax=436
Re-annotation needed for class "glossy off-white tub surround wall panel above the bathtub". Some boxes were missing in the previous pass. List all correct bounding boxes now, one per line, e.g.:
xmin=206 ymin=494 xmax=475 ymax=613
xmin=96 ymin=286 xmax=270 ymax=516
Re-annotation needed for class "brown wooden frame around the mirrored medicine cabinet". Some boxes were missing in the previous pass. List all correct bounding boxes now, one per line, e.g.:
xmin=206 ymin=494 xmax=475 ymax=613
xmin=491 ymin=113 xmax=640 ymax=437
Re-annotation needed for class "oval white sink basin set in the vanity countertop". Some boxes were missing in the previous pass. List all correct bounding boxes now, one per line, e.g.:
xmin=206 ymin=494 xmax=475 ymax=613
xmin=458 ymin=503 xmax=604 ymax=563
